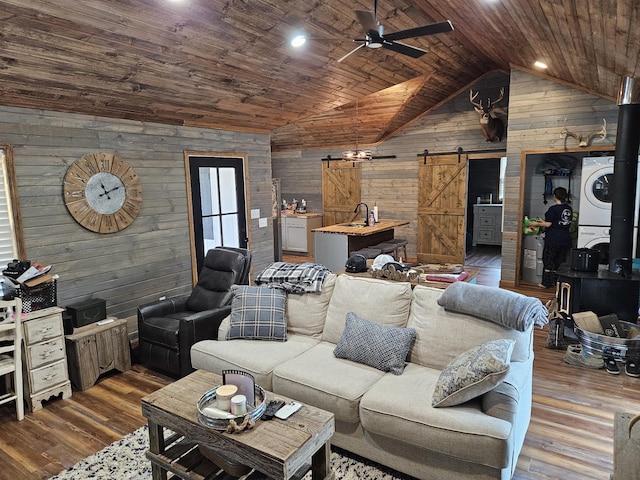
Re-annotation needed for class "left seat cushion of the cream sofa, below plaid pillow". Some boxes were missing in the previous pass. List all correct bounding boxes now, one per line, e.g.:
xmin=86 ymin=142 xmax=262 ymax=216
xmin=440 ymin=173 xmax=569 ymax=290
xmin=191 ymin=335 xmax=319 ymax=390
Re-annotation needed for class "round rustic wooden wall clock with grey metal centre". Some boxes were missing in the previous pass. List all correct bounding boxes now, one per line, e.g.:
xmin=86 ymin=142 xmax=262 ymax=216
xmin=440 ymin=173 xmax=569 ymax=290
xmin=64 ymin=152 xmax=142 ymax=233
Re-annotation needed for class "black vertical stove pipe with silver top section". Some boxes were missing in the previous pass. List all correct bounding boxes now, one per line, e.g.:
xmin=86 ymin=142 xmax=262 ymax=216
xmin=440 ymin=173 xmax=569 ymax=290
xmin=609 ymin=77 xmax=640 ymax=275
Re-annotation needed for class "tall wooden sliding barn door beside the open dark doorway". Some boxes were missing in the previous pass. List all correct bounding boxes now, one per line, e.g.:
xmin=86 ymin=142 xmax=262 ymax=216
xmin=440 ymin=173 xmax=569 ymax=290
xmin=418 ymin=155 xmax=467 ymax=264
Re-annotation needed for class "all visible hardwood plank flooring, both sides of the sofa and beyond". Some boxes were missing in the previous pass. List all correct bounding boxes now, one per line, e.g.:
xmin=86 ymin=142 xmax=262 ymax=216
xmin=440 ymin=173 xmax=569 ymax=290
xmin=0 ymin=256 xmax=640 ymax=480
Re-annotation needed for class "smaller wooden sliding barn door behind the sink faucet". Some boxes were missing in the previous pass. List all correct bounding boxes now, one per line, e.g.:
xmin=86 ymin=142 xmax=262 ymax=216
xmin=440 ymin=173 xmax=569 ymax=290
xmin=322 ymin=160 xmax=361 ymax=226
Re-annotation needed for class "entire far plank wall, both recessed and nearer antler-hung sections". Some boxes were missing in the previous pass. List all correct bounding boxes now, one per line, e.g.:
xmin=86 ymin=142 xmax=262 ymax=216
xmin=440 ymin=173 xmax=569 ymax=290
xmin=272 ymin=70 xmax=618 ymax=285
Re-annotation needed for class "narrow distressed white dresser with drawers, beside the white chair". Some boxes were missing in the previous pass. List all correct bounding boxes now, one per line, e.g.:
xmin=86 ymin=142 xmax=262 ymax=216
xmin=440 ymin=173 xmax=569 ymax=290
xmin=22 ymin=307 xmax=71 ymax=412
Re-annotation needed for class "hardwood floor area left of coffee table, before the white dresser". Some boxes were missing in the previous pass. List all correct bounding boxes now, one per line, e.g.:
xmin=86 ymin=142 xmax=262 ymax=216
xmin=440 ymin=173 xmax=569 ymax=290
xmin=0 ymin=365 xmax=171 ymax=480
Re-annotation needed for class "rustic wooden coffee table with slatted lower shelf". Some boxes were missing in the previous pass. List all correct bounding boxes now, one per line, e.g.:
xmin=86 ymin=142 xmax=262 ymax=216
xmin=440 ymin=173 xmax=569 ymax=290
xmin=142 ymin=370 xmax=335 ymax=480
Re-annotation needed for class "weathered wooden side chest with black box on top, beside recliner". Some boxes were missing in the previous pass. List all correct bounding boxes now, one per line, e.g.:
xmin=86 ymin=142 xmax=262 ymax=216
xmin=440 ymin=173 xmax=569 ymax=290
xmin=65 ymin=319 xmax=131 ymax=390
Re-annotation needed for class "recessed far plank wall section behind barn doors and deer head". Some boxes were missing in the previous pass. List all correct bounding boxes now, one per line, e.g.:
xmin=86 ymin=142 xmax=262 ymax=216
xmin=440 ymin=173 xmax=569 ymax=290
xmin=272 ymin=74 xmax=509 ymax=258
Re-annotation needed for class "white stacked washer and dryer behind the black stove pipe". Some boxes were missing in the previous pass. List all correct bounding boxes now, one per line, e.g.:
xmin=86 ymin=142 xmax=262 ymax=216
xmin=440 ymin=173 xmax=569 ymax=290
xmin=577 ymin=156 xmax=640 ymax=264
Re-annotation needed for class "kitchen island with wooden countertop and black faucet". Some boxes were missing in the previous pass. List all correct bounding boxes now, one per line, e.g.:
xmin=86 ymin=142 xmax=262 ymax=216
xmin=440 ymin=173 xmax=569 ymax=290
xmin=312 ymin=220 xmax=409 ymax=272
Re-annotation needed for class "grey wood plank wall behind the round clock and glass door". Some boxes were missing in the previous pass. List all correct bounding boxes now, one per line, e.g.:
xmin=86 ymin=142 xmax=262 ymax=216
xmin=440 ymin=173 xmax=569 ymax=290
xmin=0 ymin=107 xmax=273 ymax=318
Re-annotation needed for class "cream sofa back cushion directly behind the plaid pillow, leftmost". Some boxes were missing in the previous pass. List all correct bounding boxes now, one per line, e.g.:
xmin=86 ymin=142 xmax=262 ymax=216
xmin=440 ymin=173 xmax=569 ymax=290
xmin=287 ymin=273 xmax=337 ymax=339
